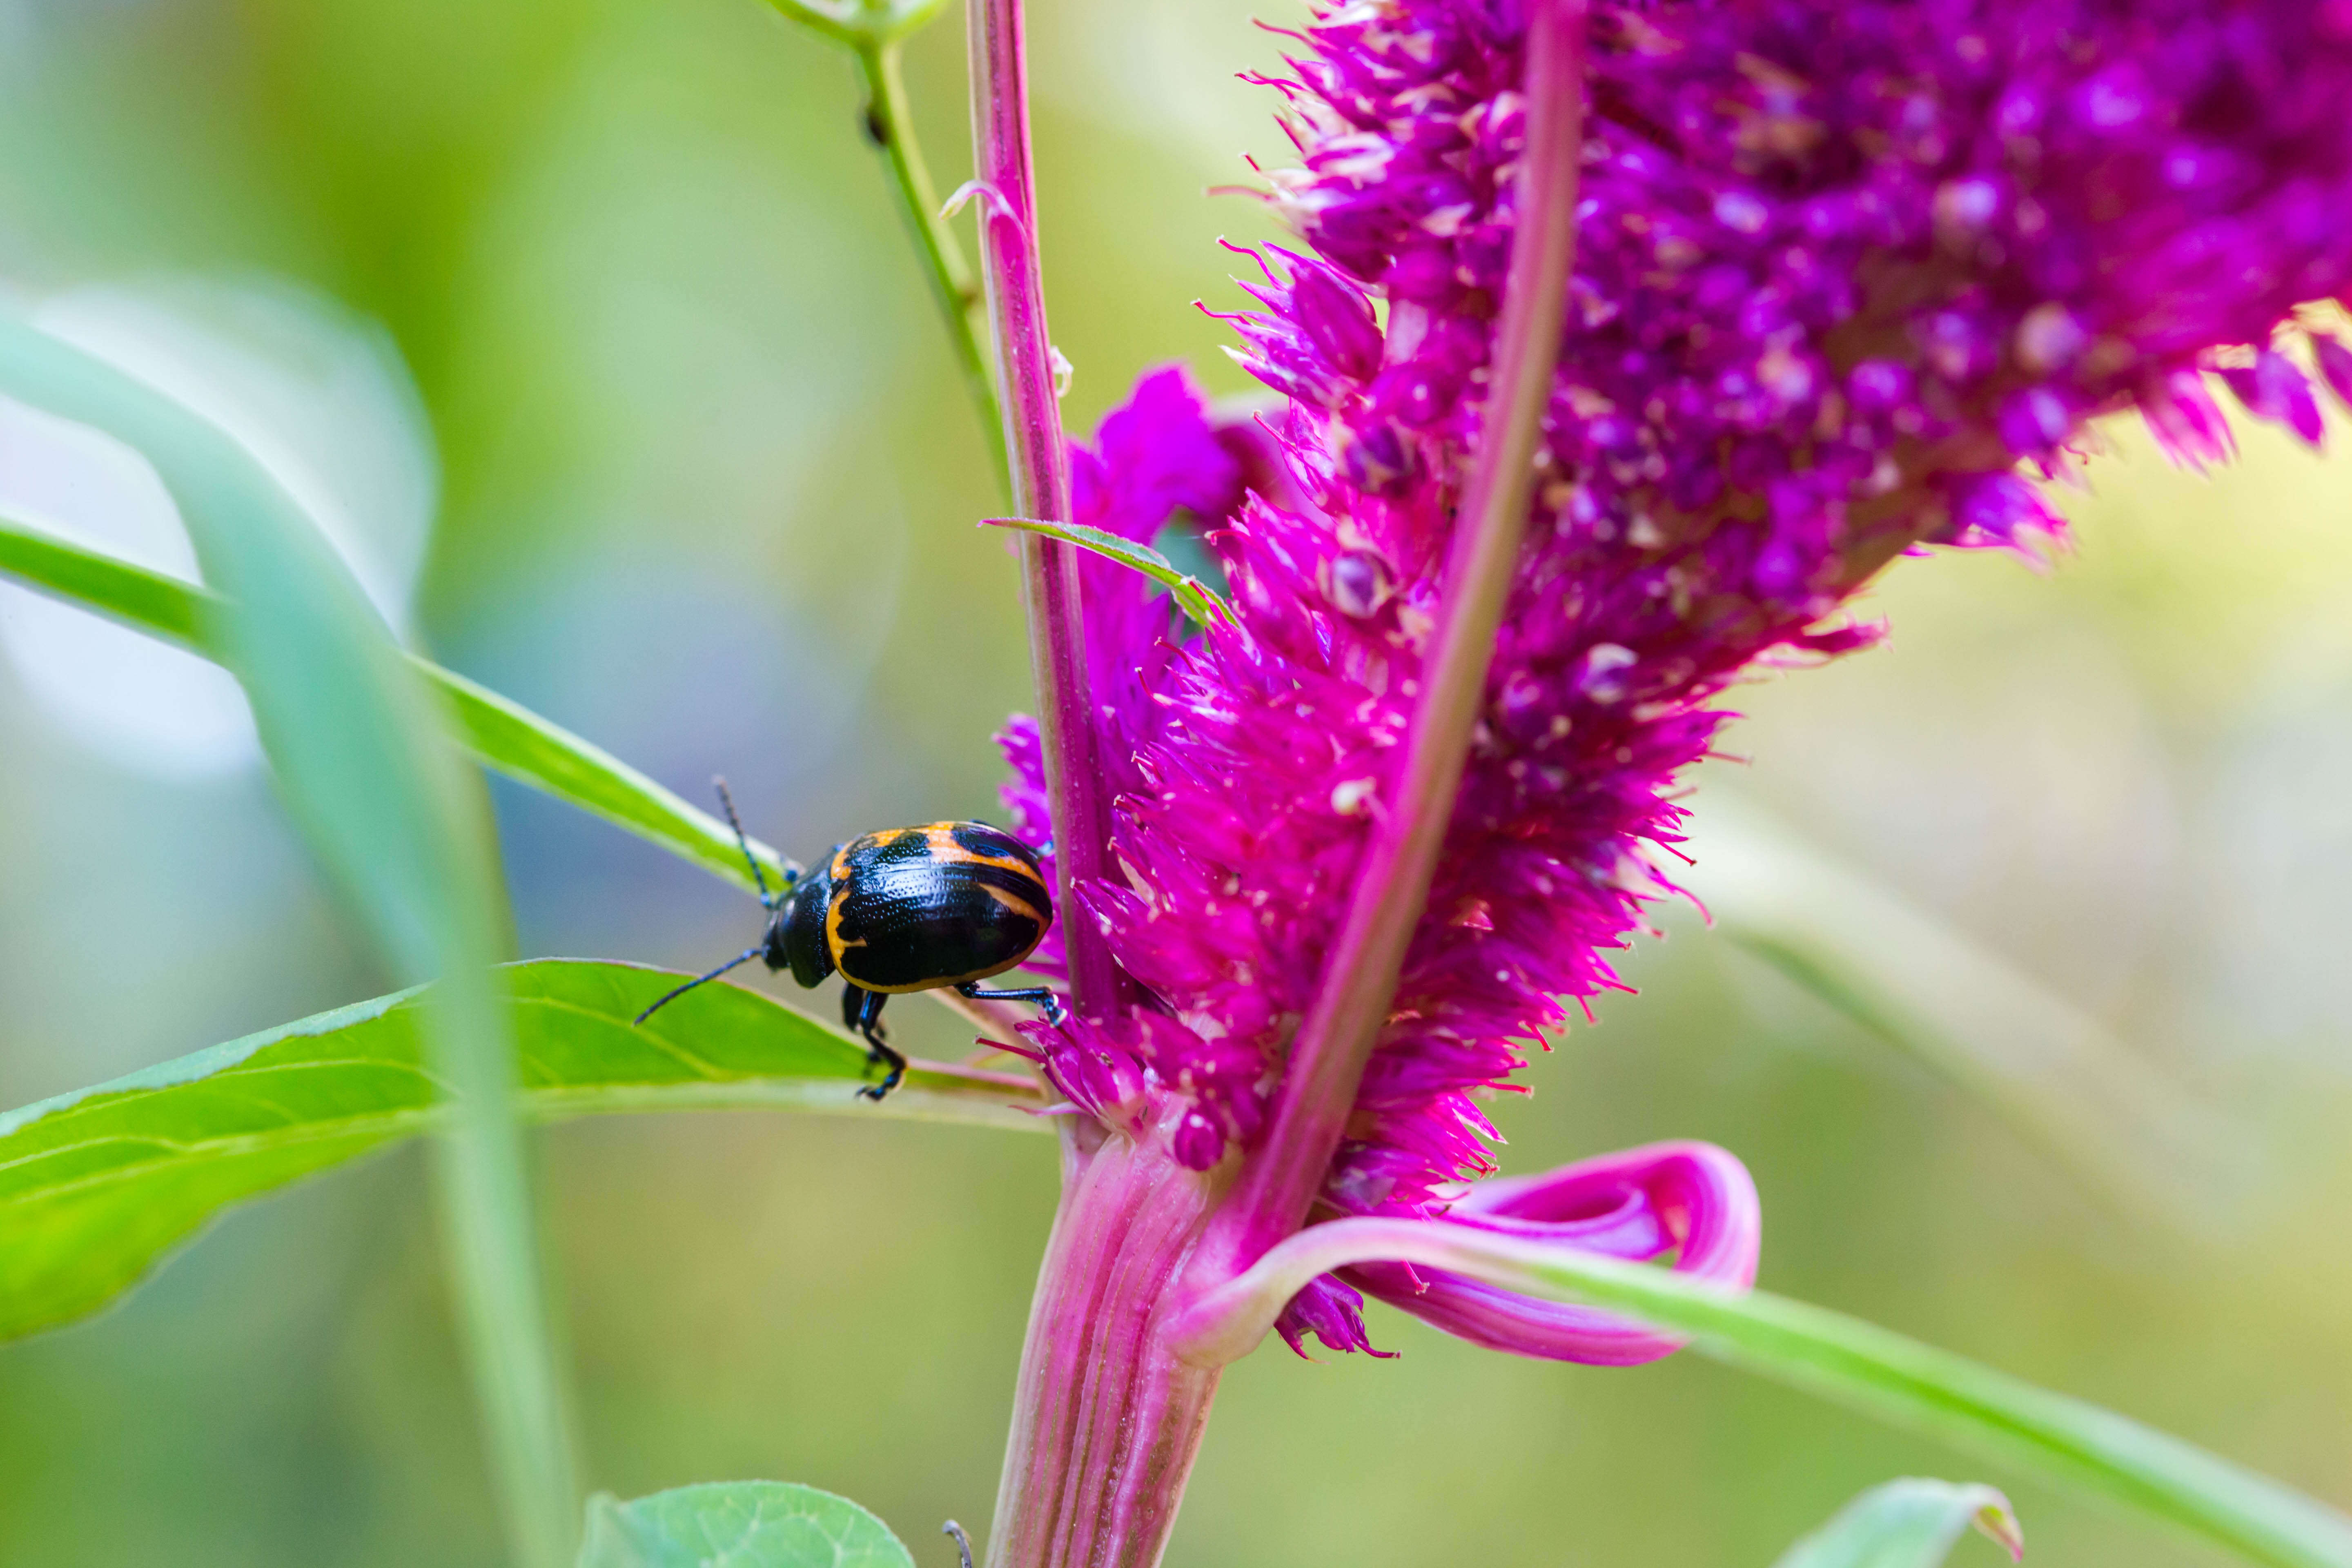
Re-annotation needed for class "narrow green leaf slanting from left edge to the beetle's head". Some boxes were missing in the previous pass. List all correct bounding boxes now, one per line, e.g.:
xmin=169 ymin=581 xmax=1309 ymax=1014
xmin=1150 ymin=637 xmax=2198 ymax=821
xmin=0 ymin=517 xmax=790 ymax=891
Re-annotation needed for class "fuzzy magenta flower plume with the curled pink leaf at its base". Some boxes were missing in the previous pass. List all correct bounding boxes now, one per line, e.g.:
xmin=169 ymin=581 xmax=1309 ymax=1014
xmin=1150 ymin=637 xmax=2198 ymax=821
xmin=1007 ymin=0 xmax=2352 ymax=1361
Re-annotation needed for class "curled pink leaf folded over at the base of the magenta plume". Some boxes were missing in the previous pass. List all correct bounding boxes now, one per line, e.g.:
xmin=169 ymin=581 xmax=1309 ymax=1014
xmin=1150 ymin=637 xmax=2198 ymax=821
xmin=1341 ymin=1143 xmax=1764 ymax=1366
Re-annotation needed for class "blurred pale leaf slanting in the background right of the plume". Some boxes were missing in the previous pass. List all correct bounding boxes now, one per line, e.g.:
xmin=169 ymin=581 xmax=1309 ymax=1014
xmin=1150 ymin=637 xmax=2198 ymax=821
xmin=1686 ymin=792 xmax=2227 ymax=1218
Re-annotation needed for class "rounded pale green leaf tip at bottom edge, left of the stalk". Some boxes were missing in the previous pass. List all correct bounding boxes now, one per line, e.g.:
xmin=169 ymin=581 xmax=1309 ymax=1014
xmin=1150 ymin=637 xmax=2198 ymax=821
xmin=579 ymin=1481 xmax=915 ymax=1568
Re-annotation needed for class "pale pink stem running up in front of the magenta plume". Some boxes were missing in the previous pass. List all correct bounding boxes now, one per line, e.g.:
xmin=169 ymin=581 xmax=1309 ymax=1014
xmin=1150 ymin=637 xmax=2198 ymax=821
xmin=1211 ymin=0 xmax=1585 ymax=1265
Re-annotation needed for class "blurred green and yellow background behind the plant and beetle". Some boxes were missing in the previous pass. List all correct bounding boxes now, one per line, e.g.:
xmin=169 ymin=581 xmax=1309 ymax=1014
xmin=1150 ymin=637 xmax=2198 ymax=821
xmin=0 ymin=0 xmax=2352 ymax=1568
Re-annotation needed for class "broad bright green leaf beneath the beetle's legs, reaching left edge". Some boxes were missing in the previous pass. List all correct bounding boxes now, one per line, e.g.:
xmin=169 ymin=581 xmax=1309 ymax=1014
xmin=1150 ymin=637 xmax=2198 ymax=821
xmin=0 ymin=959 xmax=1051 ymax=1340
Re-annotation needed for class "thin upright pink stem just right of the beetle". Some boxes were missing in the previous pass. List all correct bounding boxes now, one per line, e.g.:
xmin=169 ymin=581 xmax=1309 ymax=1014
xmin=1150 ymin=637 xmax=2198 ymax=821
xmin=967 ymin=0 xmax=1127 ymax=1018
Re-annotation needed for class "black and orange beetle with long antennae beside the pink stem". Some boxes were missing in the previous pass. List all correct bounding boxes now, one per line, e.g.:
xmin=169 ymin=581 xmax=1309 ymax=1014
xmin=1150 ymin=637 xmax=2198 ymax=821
xmin=637 ymin=780 xmax=1061 ymax=1100
